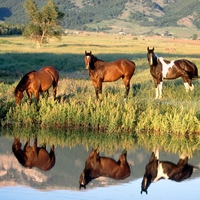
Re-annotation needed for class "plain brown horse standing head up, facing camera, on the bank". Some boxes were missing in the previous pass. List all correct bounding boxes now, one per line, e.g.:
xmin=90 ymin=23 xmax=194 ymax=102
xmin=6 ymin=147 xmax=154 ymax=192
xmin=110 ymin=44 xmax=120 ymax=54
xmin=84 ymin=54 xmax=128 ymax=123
xmin=84 ymin=51 xmax=135 ymax=100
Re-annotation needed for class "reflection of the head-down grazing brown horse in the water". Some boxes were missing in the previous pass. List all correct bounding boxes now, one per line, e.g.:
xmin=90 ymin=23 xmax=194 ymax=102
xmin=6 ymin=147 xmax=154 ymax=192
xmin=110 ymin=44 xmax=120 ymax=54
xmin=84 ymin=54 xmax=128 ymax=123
xmin=12 ymin=138 xmax=56 ymax=171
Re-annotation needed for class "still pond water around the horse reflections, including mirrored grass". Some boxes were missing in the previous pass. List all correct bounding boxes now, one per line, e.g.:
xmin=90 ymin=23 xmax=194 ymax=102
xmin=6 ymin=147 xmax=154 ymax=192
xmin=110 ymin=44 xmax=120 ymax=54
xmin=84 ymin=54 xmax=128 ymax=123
xmin=0 ymin=128 xmax=200 ymax=200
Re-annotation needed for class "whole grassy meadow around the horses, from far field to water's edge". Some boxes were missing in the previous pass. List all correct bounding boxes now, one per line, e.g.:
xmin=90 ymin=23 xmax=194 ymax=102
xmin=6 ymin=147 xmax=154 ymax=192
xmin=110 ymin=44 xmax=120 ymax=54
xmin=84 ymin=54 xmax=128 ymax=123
xmin=0 ymin=33 xmax=200 ymax=148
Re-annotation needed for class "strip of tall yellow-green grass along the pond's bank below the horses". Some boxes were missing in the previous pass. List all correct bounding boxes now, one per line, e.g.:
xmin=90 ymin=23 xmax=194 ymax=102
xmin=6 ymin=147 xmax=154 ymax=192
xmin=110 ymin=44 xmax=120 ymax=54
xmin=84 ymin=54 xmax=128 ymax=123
xmin=2 ymin=79 xmax=200 ymax=135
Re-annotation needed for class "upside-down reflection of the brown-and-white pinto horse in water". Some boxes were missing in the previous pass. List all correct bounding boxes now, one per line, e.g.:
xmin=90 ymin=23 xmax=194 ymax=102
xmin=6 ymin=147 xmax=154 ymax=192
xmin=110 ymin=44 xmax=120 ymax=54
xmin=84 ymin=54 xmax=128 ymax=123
xmin=141 ymin=150 xmax=197 ymax=194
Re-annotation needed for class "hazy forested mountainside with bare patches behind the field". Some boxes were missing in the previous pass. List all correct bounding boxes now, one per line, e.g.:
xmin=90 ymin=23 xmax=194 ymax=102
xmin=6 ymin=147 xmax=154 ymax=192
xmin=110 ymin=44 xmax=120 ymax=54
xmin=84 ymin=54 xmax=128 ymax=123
xmin=0 ymin=0 xmax=200 ymax=34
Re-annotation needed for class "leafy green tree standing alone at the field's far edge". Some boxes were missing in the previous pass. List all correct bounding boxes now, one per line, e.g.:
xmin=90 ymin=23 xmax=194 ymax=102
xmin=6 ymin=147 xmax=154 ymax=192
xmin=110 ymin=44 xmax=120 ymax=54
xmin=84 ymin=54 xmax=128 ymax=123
xmin=23 ymin=0 xmax=64 ymax=45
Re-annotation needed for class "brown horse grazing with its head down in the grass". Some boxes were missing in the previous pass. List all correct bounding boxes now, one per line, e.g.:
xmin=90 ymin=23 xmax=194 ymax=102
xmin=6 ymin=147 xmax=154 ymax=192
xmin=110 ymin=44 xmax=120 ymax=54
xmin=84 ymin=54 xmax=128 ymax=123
xmin=14 ymin=66 xmax=59 ymax=104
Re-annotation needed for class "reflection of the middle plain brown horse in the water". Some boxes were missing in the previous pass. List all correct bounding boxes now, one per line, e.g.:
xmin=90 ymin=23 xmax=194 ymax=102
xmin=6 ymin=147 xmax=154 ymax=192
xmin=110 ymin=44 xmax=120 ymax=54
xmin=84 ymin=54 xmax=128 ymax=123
xmin=79 ymin=149 xmax=130 ymax=189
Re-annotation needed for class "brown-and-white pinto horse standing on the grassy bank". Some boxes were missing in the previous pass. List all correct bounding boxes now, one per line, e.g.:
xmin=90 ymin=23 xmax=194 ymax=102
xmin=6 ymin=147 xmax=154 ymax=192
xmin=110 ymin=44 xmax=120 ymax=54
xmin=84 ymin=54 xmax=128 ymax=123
xmin=147 ymin=47 xmax=198 ymax=99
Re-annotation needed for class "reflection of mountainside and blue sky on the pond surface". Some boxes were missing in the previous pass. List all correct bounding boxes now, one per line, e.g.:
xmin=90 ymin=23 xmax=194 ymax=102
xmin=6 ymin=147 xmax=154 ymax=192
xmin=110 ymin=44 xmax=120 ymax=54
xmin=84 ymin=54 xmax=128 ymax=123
xmin=0 ymin=130 xmax=200 ymax=200
